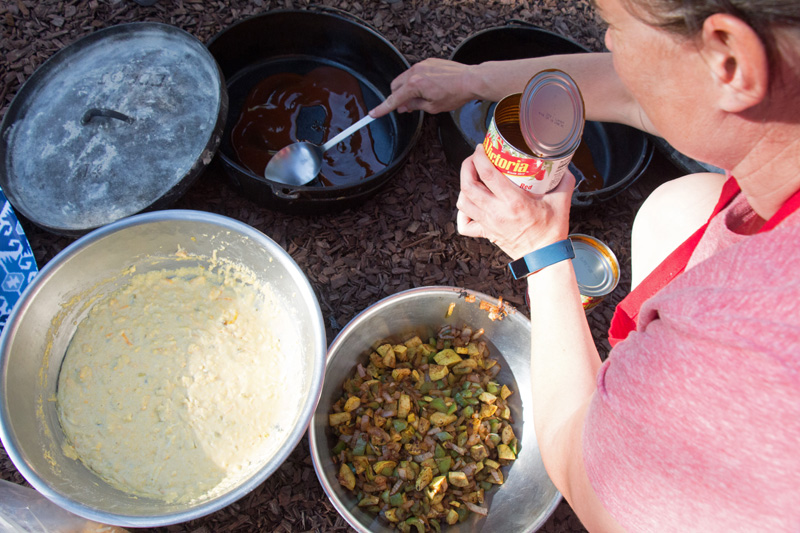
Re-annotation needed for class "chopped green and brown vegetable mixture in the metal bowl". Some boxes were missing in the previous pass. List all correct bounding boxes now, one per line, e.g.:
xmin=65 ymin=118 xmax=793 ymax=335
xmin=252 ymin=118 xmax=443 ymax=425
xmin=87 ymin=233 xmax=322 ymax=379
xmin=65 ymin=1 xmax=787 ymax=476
xmin=329 ymin=326 xmax=518 ymax=533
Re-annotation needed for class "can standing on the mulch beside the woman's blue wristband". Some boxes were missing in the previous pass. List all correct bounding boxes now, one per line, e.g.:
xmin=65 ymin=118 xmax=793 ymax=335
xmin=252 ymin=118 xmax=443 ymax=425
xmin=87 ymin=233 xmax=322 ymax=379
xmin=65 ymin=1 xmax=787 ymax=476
xmin=569 ymin=233 xmax=619 ymax=313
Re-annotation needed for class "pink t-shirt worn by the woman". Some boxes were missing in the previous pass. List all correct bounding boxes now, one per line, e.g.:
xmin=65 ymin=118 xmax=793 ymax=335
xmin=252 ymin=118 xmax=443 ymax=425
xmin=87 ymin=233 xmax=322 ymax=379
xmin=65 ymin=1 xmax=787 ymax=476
xmin=583 ymin=195 xmax=800 ymax=533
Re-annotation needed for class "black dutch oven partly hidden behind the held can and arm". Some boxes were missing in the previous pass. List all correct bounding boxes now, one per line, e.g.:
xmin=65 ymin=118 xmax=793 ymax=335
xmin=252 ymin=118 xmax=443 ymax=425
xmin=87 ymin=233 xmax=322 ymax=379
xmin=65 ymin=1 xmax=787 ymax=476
xmin=438 ymin=20 xmax=653 ymax=207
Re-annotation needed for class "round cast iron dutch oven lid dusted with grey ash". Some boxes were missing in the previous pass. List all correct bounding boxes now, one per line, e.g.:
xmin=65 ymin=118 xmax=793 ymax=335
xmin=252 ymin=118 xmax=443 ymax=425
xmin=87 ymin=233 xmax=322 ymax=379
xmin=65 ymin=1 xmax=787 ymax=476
xmin=0 ymin=22 xmax=227 ymax=235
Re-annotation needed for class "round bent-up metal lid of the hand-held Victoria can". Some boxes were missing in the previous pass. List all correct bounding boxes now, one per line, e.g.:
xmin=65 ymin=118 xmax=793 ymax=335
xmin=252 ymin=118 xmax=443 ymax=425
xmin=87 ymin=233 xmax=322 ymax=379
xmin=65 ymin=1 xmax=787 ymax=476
xmin=519 ymin=69 xmax=585 ymax=157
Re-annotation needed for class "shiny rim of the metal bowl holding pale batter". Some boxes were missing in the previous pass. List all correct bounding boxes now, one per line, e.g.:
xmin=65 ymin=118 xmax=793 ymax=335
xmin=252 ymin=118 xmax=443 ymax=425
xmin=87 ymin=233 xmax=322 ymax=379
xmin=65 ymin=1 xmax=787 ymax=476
xmin=0 ymin=209 xmax=327 ymax=528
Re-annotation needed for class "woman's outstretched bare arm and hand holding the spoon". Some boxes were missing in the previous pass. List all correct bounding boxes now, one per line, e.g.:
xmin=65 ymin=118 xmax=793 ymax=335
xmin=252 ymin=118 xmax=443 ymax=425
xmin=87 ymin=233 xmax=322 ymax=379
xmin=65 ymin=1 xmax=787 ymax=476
xmin=370 ymin=53 xmax=656 ymax=133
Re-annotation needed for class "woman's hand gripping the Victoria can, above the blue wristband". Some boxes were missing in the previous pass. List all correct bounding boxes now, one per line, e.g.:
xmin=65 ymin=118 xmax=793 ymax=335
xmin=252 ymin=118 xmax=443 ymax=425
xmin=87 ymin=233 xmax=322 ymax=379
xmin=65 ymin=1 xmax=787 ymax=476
xmin=456 ymin=145 xmax=575 ymax=259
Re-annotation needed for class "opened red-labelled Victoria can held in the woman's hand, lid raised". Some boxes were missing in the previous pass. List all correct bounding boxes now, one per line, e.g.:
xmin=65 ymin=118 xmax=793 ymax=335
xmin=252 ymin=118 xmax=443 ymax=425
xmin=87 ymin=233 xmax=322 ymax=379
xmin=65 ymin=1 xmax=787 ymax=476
xmin=483 ymin=70 xmax=585 ymax=194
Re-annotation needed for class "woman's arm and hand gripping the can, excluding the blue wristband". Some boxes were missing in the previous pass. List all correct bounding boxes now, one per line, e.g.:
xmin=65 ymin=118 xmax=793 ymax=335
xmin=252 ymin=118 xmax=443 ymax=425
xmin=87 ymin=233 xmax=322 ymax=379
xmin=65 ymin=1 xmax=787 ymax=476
xmin=458 ymin=146 xmax=619 ymax=531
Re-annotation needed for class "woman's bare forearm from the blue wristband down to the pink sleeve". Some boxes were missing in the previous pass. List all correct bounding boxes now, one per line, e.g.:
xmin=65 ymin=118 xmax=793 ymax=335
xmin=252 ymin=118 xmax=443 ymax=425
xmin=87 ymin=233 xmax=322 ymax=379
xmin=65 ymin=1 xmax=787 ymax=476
xmin=528 ymin=261 xmax=623 ymax=532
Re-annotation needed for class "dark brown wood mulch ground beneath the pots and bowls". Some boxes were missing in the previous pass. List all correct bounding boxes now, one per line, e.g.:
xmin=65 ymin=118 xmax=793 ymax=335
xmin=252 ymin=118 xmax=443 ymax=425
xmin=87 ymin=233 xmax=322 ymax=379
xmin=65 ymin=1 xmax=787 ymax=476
xmin=0 ymin=0 xmax=676 ymax=533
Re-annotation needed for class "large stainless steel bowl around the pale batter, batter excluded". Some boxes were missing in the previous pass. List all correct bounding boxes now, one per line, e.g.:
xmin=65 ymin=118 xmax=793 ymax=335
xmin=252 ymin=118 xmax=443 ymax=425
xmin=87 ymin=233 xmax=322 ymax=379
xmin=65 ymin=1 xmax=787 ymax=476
xmin=0 ymin=210 xmax=327 ymax=527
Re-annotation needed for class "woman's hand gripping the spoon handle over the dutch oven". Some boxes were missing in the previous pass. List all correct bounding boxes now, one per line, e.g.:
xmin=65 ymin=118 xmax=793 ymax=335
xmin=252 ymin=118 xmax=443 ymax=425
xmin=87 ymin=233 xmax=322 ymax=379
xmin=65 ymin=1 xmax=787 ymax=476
xmin=369 ymin=58 xmax=475 ymax=118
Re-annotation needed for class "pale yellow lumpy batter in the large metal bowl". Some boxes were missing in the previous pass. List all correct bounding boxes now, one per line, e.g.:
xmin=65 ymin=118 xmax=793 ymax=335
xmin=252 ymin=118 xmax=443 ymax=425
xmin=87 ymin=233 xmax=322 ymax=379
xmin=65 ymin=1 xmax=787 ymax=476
xmin=57 ymin=267 xmax=302 ymax=501
